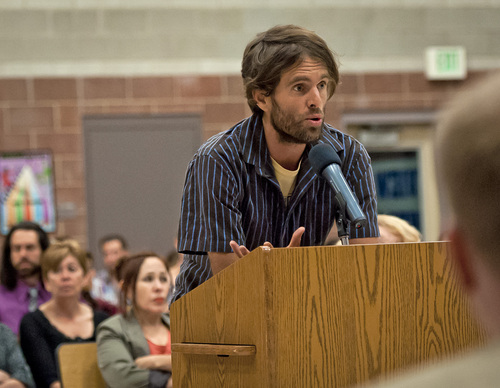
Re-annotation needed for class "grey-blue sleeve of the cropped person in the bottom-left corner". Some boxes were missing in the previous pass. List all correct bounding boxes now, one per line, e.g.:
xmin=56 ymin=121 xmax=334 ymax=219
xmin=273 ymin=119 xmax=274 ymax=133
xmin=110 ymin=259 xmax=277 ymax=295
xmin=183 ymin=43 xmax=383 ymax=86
xmin=0 ymin=325 xmax=35 ymax=388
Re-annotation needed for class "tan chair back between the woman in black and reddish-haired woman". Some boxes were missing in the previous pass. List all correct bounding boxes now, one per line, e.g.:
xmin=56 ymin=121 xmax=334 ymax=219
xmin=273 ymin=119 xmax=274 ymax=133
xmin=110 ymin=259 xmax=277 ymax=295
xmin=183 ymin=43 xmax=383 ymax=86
xmin=57 ymin=342 xmax=106 ymax=388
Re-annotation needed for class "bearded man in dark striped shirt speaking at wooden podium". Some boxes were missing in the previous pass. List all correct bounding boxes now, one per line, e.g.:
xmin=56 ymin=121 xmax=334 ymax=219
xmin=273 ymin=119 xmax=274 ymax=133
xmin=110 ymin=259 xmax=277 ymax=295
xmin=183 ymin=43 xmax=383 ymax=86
xmin=173 ymin=25 xmax=378 ymax=300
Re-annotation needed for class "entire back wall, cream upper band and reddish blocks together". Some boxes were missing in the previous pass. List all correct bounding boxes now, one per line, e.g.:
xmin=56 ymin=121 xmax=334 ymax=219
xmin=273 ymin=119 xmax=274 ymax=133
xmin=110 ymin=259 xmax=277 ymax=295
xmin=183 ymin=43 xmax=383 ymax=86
xmin=0 ymin=0 xmax=500 ymax=244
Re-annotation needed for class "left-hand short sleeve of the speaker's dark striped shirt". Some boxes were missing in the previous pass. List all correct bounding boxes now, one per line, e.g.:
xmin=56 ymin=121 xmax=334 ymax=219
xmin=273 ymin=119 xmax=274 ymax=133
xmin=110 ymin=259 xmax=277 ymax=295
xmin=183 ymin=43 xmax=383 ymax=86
xmin=179 ymin=155 xmax=244 ymax=254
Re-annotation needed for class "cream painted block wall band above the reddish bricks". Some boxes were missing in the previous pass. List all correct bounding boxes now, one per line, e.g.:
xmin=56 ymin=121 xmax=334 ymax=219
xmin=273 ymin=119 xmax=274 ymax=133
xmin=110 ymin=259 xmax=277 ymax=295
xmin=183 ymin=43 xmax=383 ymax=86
xmin=0 ymin=0 xmax=500 ymax=77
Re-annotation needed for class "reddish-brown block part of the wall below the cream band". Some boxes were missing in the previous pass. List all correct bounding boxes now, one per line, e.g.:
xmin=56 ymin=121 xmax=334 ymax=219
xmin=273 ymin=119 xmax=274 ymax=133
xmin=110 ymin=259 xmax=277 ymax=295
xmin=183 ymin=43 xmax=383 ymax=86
xmin=0 ymin=72 xmax=492 ymax=244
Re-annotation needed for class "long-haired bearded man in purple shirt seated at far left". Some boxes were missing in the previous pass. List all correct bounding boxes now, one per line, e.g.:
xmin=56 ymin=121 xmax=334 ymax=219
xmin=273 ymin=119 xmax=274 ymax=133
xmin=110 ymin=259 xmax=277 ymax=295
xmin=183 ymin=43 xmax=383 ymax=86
xmin=0 ymin=221 xmax=50 ymax=335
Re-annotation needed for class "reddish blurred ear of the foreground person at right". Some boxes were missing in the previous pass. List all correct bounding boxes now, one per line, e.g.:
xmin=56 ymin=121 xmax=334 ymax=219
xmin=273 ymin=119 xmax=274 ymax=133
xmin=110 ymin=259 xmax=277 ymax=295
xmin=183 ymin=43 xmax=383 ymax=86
xmin=449 ymin=228 xmax=477 ymax=290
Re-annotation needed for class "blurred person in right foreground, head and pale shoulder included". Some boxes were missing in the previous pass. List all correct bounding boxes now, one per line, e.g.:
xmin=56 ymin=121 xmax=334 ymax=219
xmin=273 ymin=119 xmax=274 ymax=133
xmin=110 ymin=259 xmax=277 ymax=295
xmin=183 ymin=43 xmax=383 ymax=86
xmin=362 ymin=73 xmax=500 ymax=388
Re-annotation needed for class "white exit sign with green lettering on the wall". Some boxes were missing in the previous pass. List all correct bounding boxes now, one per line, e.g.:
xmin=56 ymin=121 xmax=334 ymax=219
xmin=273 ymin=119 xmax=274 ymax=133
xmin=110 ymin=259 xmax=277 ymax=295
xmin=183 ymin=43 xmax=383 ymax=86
xmin=425 ymin=46 xmax=467 ymax=80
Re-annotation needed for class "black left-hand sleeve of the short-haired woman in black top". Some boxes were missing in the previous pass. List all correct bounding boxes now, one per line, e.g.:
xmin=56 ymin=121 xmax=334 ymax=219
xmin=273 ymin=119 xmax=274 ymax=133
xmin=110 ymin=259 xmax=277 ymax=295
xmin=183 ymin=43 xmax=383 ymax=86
xmin=19 ymin=310 xmax=59 ymax=387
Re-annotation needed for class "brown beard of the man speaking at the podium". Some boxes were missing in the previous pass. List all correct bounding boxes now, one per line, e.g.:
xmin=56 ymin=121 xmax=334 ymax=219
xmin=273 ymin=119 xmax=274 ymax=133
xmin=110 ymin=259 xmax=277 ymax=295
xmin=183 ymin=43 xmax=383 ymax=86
xmin=271 ymin=99 xmax=323 ymax=144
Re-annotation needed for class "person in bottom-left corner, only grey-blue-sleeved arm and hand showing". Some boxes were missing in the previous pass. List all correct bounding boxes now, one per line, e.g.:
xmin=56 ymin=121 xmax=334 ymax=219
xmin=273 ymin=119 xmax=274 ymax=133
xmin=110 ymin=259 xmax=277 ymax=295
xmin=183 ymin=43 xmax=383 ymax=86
xmin=0 ymin=323 xmax=35 ymax=388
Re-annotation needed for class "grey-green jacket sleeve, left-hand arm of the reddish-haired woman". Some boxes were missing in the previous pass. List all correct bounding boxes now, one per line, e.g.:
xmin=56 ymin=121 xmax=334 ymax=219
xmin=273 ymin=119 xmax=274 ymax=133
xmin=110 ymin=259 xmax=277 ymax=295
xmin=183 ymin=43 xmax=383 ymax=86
xmin=97 ymin=322 xmax=150 ymax=388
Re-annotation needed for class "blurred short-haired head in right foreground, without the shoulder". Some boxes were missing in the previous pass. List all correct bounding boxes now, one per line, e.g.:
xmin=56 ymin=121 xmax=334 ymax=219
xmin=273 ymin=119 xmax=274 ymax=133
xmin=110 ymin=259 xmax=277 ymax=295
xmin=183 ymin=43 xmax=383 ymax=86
xmin=436 ymin=73 xmax=500 ymax=336
